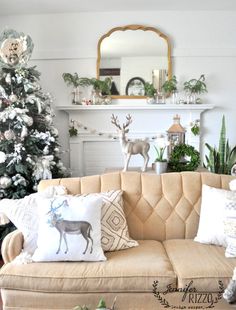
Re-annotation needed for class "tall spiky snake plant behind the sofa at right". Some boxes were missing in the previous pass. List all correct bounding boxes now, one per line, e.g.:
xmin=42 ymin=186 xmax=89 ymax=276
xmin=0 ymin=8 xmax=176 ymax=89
xmin=205 ymin=116 xmax=236 ymax=174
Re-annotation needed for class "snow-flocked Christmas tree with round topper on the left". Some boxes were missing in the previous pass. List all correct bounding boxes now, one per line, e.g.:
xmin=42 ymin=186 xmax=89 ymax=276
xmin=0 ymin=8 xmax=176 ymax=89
xmin=0 ymin=30 xmax=65 ymax=198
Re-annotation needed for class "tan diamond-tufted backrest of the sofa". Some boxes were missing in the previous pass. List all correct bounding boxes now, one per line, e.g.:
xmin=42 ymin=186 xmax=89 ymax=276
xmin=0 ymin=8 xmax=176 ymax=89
xmin=39 ymin=172 xmax=233 ymax=241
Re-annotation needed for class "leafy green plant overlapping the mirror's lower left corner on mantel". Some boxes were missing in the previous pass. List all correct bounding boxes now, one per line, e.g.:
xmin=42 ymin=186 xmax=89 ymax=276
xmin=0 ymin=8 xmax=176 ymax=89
xmin=90 ymin=77 xmax=112 ymax=104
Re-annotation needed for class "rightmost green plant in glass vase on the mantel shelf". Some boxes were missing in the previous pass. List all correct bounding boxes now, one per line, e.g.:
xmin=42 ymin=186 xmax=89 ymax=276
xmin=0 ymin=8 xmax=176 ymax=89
xmin=184 ymin=74 xmax=207 ymax=103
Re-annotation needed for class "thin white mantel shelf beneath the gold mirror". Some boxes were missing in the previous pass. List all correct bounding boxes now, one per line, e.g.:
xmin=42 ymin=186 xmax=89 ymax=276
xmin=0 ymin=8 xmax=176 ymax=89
xmin=56 ymin=104 xmax=215 ymax=113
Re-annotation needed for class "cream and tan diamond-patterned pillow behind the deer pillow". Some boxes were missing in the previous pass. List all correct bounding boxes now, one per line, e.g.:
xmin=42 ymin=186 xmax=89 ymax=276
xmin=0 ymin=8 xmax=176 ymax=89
xmin=78 ymin=190 xmax=138 ymax=252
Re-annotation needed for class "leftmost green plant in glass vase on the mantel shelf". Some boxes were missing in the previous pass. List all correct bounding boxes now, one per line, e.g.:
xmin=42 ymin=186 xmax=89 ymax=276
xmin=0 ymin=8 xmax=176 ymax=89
xmin=62 ymin=73 xmax=90 ymax=104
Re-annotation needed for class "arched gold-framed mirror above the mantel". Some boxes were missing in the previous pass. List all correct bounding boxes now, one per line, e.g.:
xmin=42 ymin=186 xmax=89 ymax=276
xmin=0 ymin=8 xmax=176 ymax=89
xmin=97 ymin=25 xmax=172 ymax=99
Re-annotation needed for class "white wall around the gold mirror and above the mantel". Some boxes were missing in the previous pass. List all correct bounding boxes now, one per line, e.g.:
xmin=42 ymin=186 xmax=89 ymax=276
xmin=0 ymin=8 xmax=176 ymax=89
xmin=0 ymin=11 xmax=236 ymax=165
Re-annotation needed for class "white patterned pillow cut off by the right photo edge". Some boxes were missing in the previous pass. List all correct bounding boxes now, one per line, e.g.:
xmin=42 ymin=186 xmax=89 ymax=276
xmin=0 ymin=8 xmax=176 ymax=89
xmin=224 ymin=199 xmax=236 ymax=257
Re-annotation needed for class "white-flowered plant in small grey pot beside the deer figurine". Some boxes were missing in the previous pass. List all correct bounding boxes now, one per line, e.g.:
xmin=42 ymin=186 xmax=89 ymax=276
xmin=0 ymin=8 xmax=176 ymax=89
xmin=154 ymin=136 xmax=170 ymax=174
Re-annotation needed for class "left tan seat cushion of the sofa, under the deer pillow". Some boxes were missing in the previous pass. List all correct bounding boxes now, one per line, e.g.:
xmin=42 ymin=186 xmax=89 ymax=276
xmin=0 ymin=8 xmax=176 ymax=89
xmin=0 ymin=240 xmax=176 ymax=293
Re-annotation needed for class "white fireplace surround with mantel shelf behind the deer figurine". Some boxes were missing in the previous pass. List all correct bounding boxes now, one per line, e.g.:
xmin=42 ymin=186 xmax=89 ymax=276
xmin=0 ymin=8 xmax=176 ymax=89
xmin=56 ymin=102 xmax=214 ymax=176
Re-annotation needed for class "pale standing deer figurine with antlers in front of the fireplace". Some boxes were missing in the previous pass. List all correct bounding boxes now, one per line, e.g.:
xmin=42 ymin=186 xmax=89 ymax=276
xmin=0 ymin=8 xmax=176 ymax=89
xmin=111 ymin=114 xmax=150 ymax=171
